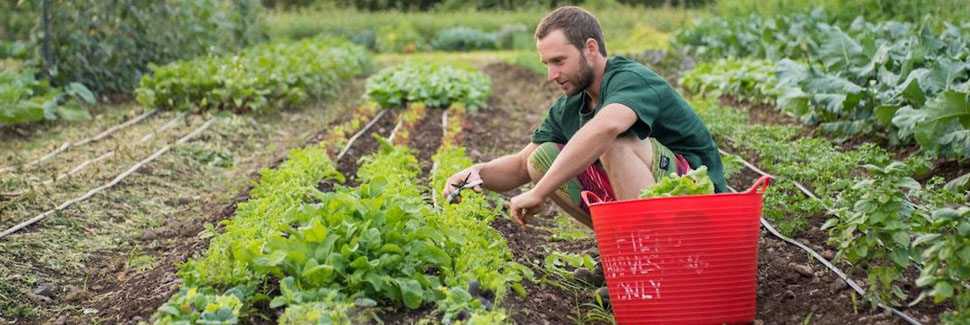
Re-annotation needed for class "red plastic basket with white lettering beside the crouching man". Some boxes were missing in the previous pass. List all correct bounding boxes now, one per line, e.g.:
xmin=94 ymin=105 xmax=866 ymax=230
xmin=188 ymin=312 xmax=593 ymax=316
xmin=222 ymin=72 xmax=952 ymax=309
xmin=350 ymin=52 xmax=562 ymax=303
xmin=582 ymin=176 xmax=770 ymax=324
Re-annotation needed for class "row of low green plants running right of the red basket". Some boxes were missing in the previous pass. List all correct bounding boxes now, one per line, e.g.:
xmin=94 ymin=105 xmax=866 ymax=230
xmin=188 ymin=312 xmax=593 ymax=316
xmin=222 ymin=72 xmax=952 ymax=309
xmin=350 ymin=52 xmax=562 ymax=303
xmin=692 ymin=99 xmax=970 ymax=323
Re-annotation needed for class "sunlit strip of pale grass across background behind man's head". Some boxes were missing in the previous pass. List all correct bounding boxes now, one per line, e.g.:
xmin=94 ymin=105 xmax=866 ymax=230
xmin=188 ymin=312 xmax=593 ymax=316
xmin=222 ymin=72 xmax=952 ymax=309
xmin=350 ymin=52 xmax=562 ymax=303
xmin=266 ymin=6 xmax=707 ymax=53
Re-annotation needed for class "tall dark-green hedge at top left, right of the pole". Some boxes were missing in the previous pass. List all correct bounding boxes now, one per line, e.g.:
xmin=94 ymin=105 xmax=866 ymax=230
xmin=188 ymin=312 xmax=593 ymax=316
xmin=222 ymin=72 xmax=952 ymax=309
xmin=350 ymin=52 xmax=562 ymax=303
xmin=42 ymin=0 xmax=261 ymax=93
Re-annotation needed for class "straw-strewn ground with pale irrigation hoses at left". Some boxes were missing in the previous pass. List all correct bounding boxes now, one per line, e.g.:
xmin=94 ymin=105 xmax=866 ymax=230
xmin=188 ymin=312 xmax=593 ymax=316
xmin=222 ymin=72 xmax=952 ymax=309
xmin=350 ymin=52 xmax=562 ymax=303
xmin=0 ymin=80 xmax=363 ymax=324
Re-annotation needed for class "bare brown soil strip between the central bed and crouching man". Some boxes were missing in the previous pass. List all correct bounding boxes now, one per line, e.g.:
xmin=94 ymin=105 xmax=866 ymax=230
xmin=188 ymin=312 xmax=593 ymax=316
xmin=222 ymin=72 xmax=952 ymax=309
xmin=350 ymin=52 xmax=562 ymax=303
xmin=464 ymin=64 xmax=596 ymax=324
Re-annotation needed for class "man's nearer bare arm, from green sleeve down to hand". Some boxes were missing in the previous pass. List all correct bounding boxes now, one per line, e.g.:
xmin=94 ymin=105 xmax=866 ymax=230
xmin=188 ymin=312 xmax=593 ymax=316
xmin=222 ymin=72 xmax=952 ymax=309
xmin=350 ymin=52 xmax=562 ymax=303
xmin=509 ymin=104 xmax=637 ymax=227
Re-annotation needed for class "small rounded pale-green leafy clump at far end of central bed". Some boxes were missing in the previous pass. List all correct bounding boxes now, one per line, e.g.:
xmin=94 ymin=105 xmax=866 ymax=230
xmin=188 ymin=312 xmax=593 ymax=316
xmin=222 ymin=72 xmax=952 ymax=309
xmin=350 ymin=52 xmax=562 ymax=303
xmin=365 ymin=61 xmax=492 ymax=109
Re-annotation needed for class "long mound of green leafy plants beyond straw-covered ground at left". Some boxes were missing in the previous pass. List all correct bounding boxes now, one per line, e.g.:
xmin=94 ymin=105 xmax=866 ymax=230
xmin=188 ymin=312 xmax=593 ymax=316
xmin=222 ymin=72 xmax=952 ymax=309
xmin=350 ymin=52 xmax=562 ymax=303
xmin=136 ymin=38 xmax=372 ymax=112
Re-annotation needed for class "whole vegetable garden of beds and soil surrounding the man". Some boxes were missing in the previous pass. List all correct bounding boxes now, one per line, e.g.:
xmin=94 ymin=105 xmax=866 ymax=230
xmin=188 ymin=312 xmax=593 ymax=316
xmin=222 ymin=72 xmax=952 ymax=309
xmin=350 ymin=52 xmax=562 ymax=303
xmin=0 ymin=0 xmax=970 ymax=324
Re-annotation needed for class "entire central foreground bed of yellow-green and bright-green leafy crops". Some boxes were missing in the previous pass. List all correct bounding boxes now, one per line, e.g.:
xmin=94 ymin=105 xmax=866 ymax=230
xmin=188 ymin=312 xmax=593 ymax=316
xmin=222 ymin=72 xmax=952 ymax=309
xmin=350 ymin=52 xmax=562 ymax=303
xmin=155 ymin=101 xmax=532 ymax=323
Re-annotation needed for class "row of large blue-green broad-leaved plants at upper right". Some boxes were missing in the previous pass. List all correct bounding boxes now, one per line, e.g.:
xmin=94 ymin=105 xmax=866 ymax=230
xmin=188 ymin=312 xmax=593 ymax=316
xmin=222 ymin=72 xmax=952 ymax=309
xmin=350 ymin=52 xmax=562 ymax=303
xmin=676 ymin=11 xmax=970 ymax=171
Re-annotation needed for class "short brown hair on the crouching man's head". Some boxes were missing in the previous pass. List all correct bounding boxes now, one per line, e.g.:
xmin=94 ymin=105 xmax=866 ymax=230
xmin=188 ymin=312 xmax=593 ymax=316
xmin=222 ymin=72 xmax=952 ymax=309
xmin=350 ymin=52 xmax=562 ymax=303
xmin=536 ymin=6 xmax=606 ymax=56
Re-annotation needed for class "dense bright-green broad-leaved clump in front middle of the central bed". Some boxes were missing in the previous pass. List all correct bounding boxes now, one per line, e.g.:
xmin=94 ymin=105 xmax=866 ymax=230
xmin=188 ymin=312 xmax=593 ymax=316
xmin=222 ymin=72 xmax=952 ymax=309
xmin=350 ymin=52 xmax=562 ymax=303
xmin=253 ymin=178 xmax=452 ymax=309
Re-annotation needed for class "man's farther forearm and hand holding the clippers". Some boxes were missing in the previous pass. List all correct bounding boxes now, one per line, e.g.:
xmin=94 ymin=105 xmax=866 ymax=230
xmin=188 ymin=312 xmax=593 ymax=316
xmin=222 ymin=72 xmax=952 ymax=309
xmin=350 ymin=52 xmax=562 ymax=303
xmin=442 ymin=143 xmax=539 ymax=197
